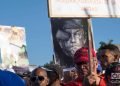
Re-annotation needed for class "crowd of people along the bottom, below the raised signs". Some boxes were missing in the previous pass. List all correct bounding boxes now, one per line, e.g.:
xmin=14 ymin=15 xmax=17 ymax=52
xmin=0 ymin=44 xmax=120 ymax=86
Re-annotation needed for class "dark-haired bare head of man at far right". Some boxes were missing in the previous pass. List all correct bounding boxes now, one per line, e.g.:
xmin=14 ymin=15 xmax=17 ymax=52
xmin=98 ymin=44 xmax=120 ymax=69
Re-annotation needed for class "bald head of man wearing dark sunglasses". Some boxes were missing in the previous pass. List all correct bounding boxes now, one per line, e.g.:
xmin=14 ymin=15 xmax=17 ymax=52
xmin=30 ymin=67 xmax=49 ymax=86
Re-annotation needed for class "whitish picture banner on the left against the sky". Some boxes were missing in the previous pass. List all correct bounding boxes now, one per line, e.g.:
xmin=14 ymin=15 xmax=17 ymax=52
xmin=0 ymin=25 xmax=29 ymax=67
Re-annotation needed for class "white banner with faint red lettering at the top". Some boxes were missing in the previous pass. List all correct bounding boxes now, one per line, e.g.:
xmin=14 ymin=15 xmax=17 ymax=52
xmin=48 ymin=0 xmax=120 ymax=17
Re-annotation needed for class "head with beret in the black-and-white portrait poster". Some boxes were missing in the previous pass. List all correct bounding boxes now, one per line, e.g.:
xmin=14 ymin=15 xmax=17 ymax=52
xmin=53 ymin=18 xmax=86 ymax=57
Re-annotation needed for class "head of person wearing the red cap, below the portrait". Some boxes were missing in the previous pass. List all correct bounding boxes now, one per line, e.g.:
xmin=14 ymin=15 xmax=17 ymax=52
xmin=74 ymin=47 xmax=96 ymax=76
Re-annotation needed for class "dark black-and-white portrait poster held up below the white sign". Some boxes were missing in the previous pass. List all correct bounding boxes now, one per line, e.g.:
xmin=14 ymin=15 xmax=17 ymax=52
xmin=51 ymin=18 xmax=87 ymax=67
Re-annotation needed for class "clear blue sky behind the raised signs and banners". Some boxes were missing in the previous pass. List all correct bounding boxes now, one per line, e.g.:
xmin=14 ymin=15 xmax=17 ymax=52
xmin=0 ymin=0 xmax=120 ymax=65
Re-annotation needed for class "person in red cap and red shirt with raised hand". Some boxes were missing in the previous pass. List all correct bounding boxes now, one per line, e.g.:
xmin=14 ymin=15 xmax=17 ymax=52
xmin=66 ymin=47 xmax=106 ymax=86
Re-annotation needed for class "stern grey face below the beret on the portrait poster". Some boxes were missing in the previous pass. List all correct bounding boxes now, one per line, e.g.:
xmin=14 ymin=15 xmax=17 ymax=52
xmin=56 ymin=28 xmax=86 ymax=57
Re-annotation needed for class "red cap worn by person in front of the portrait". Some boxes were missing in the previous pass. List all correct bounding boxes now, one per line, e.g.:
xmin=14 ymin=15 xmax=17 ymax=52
xmin=74 ymin=47 xmax=96 ymax=63
